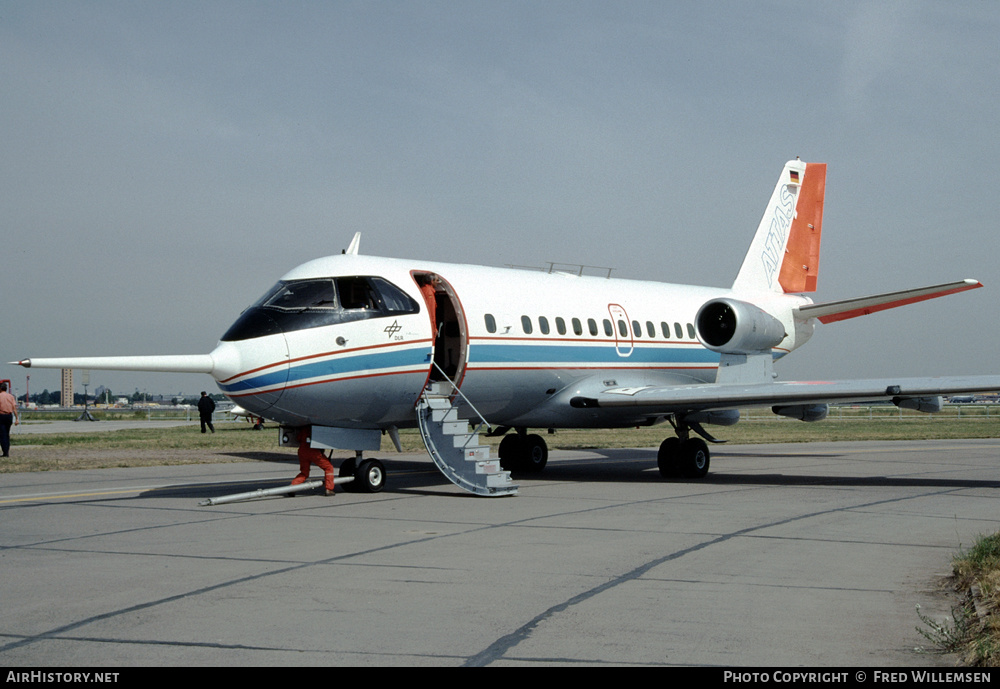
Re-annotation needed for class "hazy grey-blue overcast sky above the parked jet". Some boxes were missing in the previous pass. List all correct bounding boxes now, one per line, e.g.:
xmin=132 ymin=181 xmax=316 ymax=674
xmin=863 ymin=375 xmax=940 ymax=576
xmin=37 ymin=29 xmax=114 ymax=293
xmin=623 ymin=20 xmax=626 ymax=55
xmin=0 ymin=0 xmax=1000 ymax=394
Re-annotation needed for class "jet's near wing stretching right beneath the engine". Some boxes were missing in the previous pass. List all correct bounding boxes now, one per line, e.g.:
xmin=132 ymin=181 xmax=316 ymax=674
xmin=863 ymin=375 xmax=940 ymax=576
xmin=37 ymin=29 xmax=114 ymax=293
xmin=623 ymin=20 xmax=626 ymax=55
xmin=570 ymin=375 xmax=1000 ymax=415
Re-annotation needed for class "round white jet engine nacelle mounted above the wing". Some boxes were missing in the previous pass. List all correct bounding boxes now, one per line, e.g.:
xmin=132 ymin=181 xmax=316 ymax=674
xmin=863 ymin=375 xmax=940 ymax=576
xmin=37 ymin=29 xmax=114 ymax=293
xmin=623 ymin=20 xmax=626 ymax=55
xmin=695 ymin=298 xmax=785 ymax=354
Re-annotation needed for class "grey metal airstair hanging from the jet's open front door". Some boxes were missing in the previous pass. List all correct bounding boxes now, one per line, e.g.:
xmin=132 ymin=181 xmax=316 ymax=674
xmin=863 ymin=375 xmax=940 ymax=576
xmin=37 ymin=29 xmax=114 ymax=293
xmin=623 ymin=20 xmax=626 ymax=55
xmin=417 ymin=381 xmax=517 ymax=497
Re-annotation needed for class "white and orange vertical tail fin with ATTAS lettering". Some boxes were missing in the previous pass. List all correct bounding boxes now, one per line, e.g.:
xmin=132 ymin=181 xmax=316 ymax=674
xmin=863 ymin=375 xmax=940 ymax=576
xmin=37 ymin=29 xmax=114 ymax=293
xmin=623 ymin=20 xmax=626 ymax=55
xmin=733 ymin=160 xmax=826 ymax=292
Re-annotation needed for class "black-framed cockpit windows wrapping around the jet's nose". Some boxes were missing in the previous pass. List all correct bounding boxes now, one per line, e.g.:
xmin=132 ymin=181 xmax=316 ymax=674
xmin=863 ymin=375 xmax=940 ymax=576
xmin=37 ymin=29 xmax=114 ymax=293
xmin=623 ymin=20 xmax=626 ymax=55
xmin=222 ymin=276 xmax=420 ymax=341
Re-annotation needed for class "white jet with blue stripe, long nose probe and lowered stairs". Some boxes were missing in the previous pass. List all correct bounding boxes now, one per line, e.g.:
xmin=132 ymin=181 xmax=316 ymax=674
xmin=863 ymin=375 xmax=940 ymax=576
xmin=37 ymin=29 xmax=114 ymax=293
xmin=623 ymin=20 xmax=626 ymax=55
xmin=9 ymin=160 xmax=1000 ymax=495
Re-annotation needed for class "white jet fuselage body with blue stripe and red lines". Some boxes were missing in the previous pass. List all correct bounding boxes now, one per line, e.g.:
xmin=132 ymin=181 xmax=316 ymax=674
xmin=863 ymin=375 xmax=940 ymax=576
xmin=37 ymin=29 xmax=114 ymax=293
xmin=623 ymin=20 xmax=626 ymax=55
xmin=213 ymin=254 xmax=811 ymax=429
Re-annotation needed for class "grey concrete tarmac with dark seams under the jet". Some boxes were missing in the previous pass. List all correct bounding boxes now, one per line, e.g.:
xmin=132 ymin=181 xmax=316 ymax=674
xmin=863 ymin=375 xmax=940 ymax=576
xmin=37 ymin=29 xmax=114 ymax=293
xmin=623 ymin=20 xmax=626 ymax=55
xmin=0 ymin=440 xmax=1000 ymax=669
